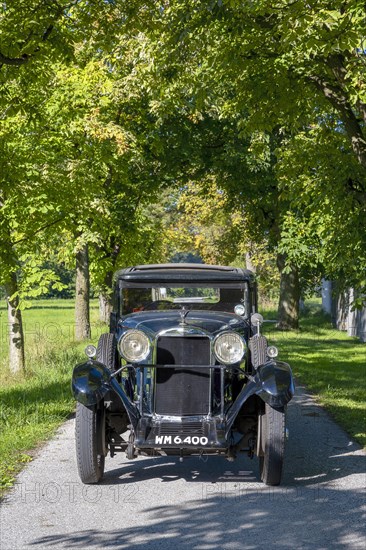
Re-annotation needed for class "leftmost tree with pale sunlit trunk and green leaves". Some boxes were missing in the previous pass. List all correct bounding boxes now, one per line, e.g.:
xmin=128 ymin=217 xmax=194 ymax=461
xmin=0 ymin=47 xmax=113 ymax=358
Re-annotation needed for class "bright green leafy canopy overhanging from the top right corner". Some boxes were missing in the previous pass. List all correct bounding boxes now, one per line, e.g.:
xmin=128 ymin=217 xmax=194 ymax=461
xmin=148 ymin=0 xmax=366 ymax=167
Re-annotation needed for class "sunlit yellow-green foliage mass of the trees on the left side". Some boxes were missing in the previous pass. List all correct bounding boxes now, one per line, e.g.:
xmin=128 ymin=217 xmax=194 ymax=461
xmin=0 ymin=29 xmax=171 ymax=310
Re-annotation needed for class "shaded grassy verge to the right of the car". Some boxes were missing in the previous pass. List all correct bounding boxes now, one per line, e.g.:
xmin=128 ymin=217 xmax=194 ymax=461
xmin=265 ymin=303 xmax=366 ymax=447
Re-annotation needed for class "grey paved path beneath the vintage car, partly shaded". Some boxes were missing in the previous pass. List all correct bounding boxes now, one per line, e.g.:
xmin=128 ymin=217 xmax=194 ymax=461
xmin=0 ymin=388 xmax=366 ymax=550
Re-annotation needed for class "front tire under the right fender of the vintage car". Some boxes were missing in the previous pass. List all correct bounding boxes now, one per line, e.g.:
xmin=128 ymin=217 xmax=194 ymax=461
xmin=259 ymin=403 xmax=286 ymax=485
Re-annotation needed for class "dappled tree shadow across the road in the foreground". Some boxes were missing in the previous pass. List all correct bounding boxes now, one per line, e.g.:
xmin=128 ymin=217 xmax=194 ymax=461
xmin=30 ymin=491 xmax=365 ymax=550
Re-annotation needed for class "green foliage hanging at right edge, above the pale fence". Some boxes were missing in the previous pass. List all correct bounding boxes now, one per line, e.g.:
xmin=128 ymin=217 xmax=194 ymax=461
xmin=277 ymin=119 xmax=366 ymax=289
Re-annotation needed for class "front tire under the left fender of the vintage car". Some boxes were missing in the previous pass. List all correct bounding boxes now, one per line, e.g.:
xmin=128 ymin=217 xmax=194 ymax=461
xmin=75 ymin=401 xmax=105 ymax=483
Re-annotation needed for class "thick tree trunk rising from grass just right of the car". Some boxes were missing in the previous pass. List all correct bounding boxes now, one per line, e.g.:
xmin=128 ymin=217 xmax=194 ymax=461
xmin=277 ymin=254 xmax=300 ymax=330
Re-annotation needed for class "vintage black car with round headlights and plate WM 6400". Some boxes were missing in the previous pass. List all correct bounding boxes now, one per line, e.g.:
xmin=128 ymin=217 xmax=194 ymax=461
xmin=72 ymin=264 xmax=294 ymax=485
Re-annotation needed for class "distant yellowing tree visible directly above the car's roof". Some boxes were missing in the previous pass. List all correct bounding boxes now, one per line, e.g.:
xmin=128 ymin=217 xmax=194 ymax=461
xmin=148 ymin=180 xmax=279 ymax=299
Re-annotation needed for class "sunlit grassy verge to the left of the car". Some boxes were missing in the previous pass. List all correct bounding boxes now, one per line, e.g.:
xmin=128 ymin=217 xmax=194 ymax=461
xmin=0 ymin=300 xmax=105 ymax=494
